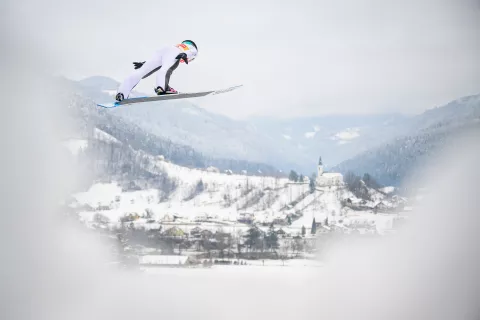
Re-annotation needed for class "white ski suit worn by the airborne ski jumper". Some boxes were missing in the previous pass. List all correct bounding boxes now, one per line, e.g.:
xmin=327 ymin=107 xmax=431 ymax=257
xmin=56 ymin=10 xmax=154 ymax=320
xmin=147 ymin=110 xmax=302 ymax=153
xmin=117 ymin=43 xmax=198 ymax=99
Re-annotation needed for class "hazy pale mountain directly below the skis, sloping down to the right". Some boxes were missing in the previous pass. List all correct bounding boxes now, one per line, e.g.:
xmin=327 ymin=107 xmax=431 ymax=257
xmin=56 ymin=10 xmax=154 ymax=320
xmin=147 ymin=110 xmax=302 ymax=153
xmin=73 ymin=77 xmax=316 ymax=171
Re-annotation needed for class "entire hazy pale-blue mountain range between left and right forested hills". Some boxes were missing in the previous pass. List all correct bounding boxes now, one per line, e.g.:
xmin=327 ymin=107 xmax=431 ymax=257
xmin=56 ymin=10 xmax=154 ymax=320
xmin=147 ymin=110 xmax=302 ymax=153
xmin=74 ymin=77 xmax=408 ymax=175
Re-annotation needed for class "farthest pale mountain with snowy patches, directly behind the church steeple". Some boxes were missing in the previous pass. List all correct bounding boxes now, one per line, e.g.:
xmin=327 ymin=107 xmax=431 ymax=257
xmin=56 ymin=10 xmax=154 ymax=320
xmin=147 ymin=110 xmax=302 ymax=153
xmin=250 ymin=114 xmax=409 ymax=168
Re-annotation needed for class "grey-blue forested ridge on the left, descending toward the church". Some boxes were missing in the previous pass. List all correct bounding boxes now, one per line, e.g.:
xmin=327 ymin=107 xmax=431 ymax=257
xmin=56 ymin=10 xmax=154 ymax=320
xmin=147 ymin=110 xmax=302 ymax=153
xmin=58 ymin=79 xmax=279 ymax=181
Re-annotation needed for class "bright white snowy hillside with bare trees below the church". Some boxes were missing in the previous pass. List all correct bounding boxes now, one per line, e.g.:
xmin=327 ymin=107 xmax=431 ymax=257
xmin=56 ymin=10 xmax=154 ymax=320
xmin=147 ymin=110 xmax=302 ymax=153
xmin=70 ymin=150 xmax=402 ymax=234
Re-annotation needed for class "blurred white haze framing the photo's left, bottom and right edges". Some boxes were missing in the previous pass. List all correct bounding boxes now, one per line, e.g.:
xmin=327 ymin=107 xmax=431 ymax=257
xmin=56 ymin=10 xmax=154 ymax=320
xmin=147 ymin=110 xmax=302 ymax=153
xmin=0 ymin=5 xmax=480 ymax=320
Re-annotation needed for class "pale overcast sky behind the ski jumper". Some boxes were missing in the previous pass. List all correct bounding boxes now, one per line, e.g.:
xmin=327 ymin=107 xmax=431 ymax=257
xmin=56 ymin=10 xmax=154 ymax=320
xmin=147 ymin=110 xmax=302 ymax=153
xmin=8 ymin=0 xmax=480 ymax=118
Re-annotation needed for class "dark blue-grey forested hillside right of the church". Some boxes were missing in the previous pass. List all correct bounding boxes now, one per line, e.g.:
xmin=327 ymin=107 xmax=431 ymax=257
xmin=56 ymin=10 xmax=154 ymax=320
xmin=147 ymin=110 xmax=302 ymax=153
xmin=333 ymin=95 xmax=480 ymax=185
